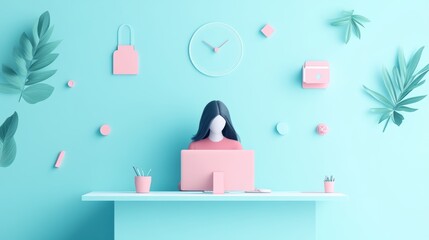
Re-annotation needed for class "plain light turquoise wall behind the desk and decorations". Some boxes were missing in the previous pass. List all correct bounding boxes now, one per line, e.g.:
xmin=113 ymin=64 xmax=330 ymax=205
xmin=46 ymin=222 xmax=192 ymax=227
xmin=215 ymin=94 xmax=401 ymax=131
xmin=0 ymin=0 xmax=429 ymax=240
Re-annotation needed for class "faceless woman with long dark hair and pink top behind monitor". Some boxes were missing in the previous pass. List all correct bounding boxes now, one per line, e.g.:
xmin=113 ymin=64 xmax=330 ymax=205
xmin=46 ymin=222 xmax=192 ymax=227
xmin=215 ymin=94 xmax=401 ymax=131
xmin=189 ymin=101 xmax=243 ymax=150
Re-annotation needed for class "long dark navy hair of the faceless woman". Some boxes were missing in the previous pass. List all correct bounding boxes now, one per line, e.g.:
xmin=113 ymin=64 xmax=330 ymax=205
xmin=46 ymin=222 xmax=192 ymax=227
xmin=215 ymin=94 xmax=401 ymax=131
xmin=192 ymin=100 xmax=239 ymax=141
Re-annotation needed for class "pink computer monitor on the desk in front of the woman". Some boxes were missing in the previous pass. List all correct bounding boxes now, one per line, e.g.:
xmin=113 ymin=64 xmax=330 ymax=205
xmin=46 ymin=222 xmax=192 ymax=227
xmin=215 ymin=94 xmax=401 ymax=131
xmin=181 ymin=150 xmax=255 ymax=193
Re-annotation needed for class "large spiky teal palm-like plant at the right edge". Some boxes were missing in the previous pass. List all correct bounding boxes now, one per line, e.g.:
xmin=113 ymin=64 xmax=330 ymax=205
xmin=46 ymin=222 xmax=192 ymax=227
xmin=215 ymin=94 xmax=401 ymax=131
xmin=363 ymin=47 xmax=429 ymax=132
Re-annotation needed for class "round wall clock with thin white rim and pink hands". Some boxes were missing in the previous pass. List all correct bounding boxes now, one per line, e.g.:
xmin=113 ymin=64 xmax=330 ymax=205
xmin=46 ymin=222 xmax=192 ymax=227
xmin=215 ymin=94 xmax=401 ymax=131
xmin=189 ymin=22 xmax=243 ymax=77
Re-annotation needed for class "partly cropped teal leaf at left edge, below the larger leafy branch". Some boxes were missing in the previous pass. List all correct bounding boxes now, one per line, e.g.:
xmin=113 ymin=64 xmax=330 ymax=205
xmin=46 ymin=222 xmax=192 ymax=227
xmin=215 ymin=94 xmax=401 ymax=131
xmin=0 ymin=112 xmax=18 ymax=167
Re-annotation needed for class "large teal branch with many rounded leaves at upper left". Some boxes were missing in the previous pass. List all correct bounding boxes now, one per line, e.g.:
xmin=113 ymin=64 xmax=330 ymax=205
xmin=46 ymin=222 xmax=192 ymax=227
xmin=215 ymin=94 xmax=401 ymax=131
xmin=0 ymin=11 xmax=61 ymax=104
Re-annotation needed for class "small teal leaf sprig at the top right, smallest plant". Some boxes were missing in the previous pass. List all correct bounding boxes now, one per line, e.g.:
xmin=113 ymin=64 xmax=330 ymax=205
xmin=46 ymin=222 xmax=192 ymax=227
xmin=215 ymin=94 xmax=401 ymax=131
xmin=331 ymin=10 xmax=370 ymax=44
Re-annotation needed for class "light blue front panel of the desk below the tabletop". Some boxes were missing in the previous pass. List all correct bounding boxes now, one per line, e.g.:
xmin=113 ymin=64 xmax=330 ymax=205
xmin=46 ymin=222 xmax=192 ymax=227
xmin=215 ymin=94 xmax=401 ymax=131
xmin=115 ymin=202 xmax=316 ymax=240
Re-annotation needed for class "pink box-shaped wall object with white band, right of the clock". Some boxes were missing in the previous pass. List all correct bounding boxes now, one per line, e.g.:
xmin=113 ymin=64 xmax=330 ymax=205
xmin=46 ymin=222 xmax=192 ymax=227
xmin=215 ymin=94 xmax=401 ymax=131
xmin=302 ymin=61 xmax=330 ymax=88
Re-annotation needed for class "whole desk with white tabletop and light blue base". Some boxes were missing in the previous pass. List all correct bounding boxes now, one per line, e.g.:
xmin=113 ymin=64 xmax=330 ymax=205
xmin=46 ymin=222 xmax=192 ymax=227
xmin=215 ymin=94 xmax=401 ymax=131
xmin=82 ymin=191 xmax=347 ymax=240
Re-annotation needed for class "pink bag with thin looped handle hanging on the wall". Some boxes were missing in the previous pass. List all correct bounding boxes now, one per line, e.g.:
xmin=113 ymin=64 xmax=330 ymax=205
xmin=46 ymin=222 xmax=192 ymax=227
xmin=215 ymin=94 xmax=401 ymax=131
xmin=113 ymin=24 xmax=139 ymax=74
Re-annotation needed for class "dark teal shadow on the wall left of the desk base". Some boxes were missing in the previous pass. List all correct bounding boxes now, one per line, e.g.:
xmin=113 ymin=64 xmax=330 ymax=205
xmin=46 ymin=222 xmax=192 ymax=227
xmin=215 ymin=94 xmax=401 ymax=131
xmin=61 ymin=202 xmax=114 ymax=240
